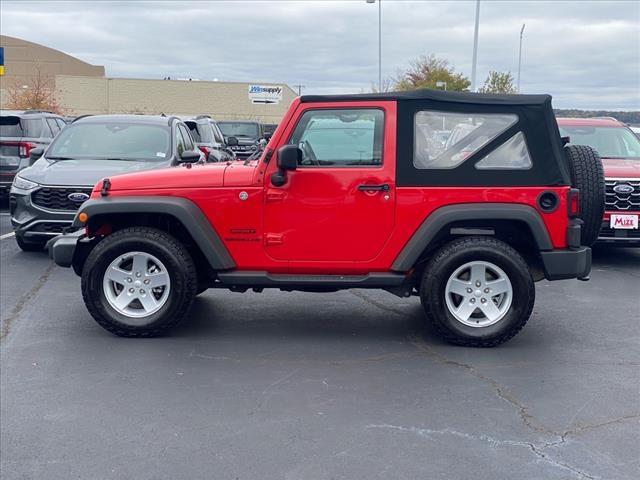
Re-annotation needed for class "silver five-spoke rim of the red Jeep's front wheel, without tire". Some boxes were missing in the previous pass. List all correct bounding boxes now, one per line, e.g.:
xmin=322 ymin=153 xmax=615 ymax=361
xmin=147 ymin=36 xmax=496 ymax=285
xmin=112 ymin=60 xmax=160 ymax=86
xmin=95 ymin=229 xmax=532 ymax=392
xmin=102 ymin=252 xmax=171 ymax=325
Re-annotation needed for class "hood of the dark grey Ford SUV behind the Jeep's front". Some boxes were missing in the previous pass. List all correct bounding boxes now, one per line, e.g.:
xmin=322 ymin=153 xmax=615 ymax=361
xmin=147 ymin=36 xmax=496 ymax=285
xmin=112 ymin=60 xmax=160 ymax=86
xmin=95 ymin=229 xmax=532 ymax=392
xmin=20 ymin=158 xmax=169 ymax=186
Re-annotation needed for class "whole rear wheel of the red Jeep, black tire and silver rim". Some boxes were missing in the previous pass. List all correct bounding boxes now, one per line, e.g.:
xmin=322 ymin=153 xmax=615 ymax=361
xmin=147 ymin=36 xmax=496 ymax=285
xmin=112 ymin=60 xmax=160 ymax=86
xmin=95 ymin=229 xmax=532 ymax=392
xmin=420 ymin=237 xmax=535 ymax=347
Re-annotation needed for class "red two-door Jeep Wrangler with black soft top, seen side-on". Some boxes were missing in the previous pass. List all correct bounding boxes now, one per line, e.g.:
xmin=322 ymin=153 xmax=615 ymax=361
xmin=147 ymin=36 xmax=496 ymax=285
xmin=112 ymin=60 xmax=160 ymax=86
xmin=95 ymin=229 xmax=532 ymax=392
xmin=49 ymin=90 xmax=604 ymax=347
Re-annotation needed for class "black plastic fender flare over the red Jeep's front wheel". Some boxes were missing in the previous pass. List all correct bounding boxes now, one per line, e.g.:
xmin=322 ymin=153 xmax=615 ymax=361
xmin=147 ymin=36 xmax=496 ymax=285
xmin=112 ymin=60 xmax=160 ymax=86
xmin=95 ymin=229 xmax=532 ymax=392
xmin=72 ymin=196 xmax=236 ymax=270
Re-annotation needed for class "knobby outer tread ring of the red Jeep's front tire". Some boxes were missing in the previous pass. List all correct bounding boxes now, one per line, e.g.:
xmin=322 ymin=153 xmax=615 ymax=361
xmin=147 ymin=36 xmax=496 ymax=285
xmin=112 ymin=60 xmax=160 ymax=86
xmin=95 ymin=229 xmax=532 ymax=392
xmin=82 ymin=227 xmax=198 ymax=338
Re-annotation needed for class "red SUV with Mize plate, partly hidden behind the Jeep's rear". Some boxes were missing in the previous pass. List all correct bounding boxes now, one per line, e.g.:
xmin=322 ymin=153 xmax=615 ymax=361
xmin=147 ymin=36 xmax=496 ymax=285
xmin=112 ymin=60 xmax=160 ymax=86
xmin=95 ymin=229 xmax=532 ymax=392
xmin=558 ymin=118 xmax=640 ymax=246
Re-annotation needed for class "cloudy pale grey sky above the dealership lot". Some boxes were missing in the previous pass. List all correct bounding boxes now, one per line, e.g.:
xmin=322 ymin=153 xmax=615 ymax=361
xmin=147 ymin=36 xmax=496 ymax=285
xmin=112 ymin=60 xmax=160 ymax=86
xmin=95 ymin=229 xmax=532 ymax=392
xmin=0 ymin=0 xmax=640 ymax=110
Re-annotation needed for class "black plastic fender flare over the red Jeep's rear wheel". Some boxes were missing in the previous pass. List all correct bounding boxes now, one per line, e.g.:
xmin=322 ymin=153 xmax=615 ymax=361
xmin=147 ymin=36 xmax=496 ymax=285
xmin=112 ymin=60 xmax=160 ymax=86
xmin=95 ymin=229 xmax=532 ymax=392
xmin=391 ymin=203 xmax=553 ymax=272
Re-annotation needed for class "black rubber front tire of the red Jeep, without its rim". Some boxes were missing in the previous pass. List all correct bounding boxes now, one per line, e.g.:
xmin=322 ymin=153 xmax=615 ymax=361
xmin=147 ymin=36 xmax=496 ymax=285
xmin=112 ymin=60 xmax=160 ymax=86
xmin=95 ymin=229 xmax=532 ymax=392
xmin=82 ymin=227 xmax=198 ymax=337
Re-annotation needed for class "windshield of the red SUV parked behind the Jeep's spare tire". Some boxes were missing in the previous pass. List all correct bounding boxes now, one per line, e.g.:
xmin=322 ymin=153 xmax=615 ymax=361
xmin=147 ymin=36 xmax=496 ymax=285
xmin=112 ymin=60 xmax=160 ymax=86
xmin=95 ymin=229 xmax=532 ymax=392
xmin=560 ymin=126 xmax=640 ymax=161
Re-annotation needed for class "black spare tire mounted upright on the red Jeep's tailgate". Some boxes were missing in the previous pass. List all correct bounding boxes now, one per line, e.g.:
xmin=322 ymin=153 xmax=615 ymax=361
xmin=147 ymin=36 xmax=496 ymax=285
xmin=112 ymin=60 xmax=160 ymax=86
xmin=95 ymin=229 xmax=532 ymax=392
xmin=564 ymin=145 xmax=604 ymax=247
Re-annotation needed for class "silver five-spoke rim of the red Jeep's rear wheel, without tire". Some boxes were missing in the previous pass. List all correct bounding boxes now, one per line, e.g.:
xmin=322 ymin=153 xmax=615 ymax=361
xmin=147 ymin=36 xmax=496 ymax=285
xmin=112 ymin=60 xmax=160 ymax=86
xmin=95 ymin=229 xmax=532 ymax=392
xmin=445 ymin=261 xmax=513 ymax=327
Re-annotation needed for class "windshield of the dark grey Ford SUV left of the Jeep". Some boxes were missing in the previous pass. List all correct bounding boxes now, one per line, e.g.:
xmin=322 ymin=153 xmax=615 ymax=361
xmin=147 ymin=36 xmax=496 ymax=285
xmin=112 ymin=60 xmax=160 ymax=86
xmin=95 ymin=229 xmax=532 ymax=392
xmin=46 ymin=122 xmax=171 ymax=162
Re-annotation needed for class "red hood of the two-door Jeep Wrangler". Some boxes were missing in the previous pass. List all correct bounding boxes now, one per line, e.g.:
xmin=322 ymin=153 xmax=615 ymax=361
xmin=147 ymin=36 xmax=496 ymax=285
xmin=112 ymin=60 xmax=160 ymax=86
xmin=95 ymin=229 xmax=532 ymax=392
xmin=106 ymin=163 xmax=229 ymax=192
